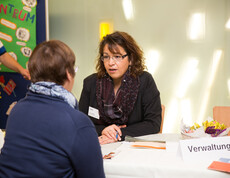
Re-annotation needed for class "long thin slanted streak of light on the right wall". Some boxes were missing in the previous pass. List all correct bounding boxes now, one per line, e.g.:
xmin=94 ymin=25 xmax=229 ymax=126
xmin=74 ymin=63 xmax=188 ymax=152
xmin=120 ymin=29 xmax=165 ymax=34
xmin=197 ymin=50 xmax=222 ymax=124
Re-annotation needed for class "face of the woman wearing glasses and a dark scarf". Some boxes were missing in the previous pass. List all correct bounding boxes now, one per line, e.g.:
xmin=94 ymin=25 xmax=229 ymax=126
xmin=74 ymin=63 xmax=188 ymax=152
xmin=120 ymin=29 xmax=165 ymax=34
xmin=103 ymin=44 xmax=131 ymax=83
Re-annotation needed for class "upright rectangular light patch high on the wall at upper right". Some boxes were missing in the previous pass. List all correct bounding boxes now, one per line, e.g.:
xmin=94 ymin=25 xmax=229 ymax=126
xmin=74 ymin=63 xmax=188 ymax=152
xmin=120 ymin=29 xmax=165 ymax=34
xmin=189 ymin=13 xmax=205 ymax=40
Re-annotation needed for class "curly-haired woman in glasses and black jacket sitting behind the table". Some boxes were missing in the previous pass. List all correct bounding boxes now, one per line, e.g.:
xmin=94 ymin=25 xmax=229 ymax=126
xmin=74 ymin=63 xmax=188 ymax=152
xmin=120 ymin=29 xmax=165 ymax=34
xmin=79 ymin=31 xmax=161 ymax=144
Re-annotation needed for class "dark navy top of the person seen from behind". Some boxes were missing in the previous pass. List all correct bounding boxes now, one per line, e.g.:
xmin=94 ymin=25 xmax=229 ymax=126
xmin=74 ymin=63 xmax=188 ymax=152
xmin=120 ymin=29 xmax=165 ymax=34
xmin=0 ymin=92 xmax=105 ymax=178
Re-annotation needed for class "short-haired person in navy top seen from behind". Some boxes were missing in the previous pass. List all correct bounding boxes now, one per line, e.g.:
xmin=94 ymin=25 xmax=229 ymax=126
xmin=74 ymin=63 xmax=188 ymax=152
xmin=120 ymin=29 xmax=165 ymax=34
xmin=0 ymin=40 xmax=105 ymax=178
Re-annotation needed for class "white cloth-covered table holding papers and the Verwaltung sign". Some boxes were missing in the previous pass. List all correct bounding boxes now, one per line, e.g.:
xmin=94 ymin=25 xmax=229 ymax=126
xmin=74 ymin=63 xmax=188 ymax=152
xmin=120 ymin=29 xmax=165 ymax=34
xmin=101 ymin=134 xmax=230 ymax=178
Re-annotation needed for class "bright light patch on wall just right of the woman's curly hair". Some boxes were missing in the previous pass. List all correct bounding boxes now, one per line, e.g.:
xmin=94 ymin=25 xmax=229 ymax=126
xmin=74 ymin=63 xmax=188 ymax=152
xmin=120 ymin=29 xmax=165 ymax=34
xmin=146 ymin=50 xmax=160 ymax=75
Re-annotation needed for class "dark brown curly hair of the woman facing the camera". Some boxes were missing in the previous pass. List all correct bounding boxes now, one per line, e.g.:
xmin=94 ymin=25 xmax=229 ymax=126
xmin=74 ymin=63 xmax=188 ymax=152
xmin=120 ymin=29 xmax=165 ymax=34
xmin=96 ymin=31 xmax=146 ymax=78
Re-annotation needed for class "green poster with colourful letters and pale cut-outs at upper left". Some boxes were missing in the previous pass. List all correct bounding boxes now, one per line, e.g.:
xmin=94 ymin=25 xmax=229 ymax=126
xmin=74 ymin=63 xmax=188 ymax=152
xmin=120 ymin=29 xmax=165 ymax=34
xmin=0 ymin=0 xmax=37 ymax=72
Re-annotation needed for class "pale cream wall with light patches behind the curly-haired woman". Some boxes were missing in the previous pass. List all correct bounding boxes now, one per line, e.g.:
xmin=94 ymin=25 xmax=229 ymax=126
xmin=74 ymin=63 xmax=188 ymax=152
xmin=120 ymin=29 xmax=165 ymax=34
xmin=48 ymin=0 xmax=230 ymax=132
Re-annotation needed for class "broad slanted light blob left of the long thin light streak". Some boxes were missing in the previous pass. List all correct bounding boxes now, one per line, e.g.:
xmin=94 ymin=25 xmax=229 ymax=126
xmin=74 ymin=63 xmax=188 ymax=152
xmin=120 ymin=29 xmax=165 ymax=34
xmin=176 ymin=58 xmax=199 ymax=98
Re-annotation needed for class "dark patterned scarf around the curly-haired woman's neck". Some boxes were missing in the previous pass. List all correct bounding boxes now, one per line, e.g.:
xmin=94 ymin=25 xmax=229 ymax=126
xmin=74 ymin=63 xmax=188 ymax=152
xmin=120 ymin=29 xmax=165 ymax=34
xmin=96 ymin=71 xmax=140 ymax=125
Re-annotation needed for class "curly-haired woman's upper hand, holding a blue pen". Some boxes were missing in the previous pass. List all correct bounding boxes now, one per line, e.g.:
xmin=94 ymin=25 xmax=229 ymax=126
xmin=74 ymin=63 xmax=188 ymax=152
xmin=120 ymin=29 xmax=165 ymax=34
xmin=101 ymin=124 xmax=126 ymax=141
